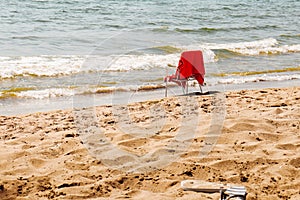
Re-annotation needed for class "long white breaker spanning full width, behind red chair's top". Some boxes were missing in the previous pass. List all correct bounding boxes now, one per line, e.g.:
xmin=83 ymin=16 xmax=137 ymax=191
xmin=0 ymin=38 xmax=300 ymax=79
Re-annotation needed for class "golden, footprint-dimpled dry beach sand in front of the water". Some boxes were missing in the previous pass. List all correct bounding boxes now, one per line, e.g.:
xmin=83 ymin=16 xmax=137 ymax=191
xmin=0 ymin=87 xmax=300 ymax=200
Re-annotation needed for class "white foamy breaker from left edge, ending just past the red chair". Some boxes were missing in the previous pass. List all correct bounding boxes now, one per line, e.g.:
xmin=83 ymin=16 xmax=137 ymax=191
xmin=0 ymin=50 xmax=215 ymax=79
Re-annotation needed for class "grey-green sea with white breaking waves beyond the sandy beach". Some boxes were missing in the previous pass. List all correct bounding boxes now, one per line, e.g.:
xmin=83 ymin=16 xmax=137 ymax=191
xmin=0 ymin=0 xmax=300 ymax=114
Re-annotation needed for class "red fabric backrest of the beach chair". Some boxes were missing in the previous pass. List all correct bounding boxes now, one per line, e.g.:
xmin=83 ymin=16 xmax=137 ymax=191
xmin=175 ymin=50 xmax=205 ymax=85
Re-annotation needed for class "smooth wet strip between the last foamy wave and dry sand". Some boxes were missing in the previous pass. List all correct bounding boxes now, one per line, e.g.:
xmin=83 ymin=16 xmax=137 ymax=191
xmin=0 ymin=79 xmax=300 ymax=116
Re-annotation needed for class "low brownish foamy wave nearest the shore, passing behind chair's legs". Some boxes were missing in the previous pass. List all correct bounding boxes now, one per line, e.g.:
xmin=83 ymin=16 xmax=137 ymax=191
xmin=0 ymin=72 xmax=300 ymax=99
